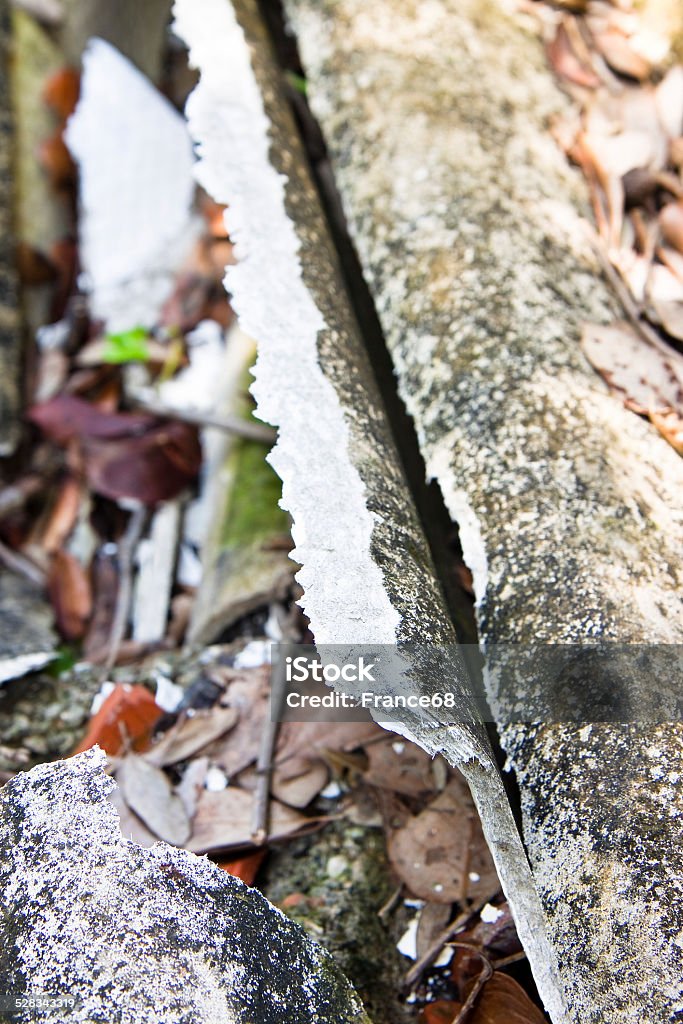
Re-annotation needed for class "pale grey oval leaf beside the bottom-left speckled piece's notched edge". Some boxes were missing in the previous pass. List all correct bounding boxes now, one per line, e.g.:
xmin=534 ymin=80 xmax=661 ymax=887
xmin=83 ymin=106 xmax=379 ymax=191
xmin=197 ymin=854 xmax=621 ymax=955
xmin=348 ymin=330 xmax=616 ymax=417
xmin=116 ymin=754 xmax=189 ymax=846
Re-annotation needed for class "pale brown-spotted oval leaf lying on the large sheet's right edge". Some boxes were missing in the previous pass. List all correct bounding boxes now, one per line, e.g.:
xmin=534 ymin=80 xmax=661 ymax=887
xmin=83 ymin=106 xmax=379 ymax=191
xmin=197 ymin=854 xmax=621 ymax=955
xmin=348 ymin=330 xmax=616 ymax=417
xmin=582 ymin=321 xmax=683 ymax=415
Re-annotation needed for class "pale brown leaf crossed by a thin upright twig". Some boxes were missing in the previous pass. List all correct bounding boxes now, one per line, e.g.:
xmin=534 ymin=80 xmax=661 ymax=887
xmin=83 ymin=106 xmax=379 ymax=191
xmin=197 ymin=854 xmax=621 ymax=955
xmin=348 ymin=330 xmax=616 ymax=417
xmin=185 ymin=785 xmax=308 ymax=853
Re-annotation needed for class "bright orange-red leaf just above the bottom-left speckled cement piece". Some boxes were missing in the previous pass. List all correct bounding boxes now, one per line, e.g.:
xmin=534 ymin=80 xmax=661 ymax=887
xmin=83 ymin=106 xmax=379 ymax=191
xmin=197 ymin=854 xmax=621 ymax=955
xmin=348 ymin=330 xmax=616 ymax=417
xmin=74 ymin=683 xmax=164 ymax=756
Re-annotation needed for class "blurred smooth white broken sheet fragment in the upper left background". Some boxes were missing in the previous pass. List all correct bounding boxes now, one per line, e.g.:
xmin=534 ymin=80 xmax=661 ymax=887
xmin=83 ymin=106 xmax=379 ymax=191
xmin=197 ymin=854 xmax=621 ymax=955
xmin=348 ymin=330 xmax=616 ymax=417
xmin=65 ymin=39 xmax=198 ymax=332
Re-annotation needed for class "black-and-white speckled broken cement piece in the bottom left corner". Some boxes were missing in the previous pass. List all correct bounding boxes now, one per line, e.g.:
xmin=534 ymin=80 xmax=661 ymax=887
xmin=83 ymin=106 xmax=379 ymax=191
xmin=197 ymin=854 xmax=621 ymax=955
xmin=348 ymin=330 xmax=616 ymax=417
xmin=0 ymin=750 xmax=368 ymax=1024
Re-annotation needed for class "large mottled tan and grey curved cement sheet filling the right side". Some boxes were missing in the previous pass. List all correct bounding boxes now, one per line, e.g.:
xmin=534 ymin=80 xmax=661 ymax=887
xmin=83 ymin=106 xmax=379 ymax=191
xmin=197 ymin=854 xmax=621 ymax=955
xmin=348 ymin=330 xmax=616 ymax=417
xmin=286 ymin=0 xmax=683 ymax=1024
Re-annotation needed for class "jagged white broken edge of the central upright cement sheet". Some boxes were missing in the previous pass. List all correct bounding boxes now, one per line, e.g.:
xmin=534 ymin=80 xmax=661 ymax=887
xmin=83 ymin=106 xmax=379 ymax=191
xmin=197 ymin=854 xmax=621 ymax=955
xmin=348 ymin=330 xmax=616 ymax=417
xmin=173 ymin=0 xmax=400 ymax=644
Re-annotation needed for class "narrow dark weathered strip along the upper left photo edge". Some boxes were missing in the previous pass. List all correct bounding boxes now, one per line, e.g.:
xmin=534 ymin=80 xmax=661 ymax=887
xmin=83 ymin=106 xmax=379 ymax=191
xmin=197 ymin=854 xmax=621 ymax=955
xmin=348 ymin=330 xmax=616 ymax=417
xmin=0 ymin=0 xmax=20 ymax=457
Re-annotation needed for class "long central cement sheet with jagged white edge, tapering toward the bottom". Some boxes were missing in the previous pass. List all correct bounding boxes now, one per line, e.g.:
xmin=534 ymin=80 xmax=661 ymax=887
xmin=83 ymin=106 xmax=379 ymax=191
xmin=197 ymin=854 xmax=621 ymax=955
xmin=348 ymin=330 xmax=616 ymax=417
xmin=174 ymin=0 xmax=565 ymax=1021
